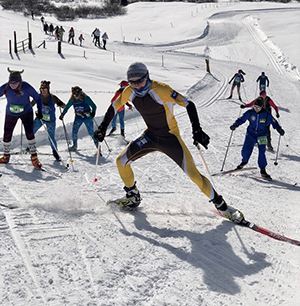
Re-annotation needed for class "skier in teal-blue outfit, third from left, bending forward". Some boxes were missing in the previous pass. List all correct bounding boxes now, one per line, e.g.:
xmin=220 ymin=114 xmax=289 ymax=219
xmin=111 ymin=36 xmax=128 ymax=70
xmin=59 ymin=86 xmax=98 ymax=151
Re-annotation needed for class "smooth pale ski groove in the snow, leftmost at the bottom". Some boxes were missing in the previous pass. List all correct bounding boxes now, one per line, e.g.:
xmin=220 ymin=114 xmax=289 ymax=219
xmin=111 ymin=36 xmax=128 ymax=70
xmin=5 ymin=211 xmax=48 ymax=305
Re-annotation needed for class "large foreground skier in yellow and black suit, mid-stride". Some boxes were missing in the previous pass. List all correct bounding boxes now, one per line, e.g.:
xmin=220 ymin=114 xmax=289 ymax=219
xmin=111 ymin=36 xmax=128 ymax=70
xmin=94 ymin=62 xmax=243 ymax=223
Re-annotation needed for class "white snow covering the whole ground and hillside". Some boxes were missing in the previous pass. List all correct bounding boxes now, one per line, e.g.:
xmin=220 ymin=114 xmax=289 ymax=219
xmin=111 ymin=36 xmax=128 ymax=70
xmin=0 ymin=2 xmax=300 ymax=306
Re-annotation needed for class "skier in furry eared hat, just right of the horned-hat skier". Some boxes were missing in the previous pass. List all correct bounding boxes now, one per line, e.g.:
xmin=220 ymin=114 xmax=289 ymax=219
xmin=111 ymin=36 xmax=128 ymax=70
xmin=31 ymin=80 xmax=66 ymax=161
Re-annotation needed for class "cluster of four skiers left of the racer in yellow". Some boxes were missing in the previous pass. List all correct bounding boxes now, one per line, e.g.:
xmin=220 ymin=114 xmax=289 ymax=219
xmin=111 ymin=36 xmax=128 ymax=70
xmin=0 ymin=68 xmax=132 ymax=168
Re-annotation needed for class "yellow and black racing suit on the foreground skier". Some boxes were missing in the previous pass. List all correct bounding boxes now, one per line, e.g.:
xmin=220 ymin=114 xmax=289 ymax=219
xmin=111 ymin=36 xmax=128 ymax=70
xmin=103 ymin=81 xmax=216 ymax=199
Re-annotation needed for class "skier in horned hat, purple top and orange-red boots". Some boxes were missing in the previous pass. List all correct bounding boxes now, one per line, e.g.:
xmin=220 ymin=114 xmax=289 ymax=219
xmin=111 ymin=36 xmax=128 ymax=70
xmin=0 ymin=68 xmax=43 ymax=168
